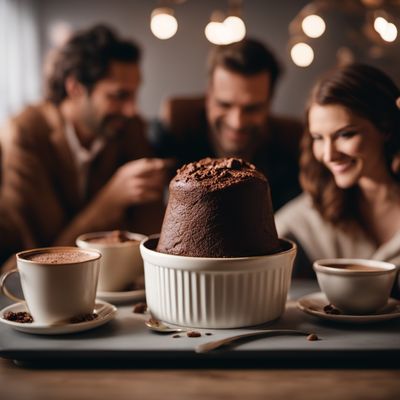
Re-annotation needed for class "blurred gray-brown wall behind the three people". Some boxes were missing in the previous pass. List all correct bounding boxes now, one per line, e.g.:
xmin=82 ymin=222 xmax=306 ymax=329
xmin=0 ymin=0 xmax=400 ymax=122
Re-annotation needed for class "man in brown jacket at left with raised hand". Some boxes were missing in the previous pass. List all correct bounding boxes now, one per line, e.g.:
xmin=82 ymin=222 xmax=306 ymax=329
xmin=1 ymin=25 xmax=170 ymax=253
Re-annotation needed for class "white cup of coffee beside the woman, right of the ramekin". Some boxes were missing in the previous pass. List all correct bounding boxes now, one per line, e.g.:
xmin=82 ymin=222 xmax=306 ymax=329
xmin=313 ymin=258 xmax=397 ymax=314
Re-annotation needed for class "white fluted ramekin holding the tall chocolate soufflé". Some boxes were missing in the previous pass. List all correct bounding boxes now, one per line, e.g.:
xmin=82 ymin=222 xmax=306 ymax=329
xmin=140 ymin=238 xmax=296 ymax=329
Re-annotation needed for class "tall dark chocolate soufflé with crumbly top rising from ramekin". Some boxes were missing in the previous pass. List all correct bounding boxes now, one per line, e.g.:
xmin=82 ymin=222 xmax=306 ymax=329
xmin=156 ymin=158 xmax=280 ymax=258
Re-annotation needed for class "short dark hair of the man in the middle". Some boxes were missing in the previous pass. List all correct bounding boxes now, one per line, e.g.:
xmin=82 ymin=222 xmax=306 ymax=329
xmin=208 ymin=38 xmax=282 ymax=93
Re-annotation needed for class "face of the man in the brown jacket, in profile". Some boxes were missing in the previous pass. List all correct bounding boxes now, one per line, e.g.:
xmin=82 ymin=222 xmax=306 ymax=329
xmin=80 ymin=61 xmax=140 ymax=136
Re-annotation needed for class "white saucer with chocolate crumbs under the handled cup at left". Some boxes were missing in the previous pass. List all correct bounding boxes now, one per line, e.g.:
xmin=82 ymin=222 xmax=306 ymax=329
xmin=0 ymin=299 xmax=117 ymax=335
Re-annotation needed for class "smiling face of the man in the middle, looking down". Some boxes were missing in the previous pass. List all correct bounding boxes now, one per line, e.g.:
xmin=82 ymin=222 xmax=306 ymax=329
xmin=207 ymin=67 xmax=270 ymax=156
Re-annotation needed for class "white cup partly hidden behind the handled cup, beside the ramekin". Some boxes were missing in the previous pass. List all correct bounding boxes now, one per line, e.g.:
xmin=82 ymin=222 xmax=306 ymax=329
xmin=76 ymin=231 xmax=146 ymax=292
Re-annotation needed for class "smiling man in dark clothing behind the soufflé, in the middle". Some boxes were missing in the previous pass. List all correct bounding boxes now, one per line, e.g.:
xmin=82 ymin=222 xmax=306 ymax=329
xmin=150 ymin=39 xmax=302 ymax=209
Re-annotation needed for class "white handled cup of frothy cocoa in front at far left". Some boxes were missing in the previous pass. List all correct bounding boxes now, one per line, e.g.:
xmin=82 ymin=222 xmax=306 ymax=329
xmin=0 ymin=247 xmax=101 ymax=325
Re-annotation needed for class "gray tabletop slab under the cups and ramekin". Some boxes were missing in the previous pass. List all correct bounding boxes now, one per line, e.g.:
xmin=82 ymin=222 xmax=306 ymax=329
xmin=0 ymin=281 xmax=400 ymax=366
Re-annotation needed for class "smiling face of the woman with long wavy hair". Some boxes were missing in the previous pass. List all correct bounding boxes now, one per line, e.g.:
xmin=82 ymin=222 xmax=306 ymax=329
xmin=308 ymin=104 xmax=388 ymax=189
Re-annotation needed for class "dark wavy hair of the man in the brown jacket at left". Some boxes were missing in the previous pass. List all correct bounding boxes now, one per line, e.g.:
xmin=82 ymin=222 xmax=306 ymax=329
xmin=46 ymin=25 xmax=141 ymax=104
